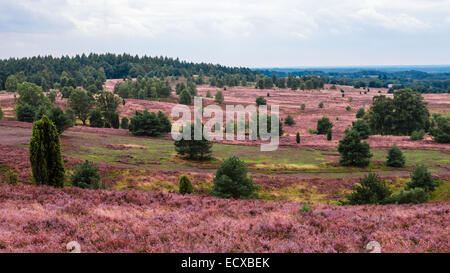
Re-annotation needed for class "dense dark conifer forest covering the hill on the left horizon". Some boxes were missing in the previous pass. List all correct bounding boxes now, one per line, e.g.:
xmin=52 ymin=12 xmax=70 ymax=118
xmin=0 ymin=53 xmax=255 ymax=91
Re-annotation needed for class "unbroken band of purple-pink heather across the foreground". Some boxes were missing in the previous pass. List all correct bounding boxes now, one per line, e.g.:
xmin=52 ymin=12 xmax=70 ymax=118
xmin=0 ymin=185 xmax=450 ymax=252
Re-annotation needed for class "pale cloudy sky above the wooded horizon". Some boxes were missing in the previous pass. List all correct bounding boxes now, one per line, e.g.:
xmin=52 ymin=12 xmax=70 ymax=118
xmin=0 ymin=0 xmax=450 ymax=67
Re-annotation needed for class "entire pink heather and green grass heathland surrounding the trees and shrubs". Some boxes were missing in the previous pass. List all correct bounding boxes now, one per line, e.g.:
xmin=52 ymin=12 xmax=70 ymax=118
xmin=0 ymin=80 xmax=450 ymax=253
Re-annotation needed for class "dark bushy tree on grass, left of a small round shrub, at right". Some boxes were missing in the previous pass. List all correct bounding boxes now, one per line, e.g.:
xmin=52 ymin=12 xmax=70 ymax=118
xmin=338 ymin=130 xmax=372 ymax=167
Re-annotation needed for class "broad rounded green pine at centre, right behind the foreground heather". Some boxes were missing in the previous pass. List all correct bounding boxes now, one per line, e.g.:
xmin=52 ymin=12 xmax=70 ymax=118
xmin=212 ymin=156 xmax=258 ymax=199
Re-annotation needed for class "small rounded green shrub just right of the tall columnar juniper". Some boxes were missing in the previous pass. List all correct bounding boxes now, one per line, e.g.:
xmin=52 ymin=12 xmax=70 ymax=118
xmin=70 ymin=160 xmax=100 ymax=189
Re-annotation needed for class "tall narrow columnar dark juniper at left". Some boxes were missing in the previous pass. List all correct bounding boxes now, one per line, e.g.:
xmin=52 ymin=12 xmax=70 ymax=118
xmin=30 ymin=115 xmax=64 ymax=187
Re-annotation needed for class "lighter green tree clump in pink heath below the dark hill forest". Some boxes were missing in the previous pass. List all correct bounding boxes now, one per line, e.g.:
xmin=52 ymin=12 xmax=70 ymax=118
xmin=114 ymin=76 xmax=172 ymax=100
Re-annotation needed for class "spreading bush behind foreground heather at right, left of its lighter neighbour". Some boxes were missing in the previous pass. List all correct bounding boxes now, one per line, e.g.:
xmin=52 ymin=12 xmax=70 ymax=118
xmin=344 ymin=173 xmax=391 ymax=205
